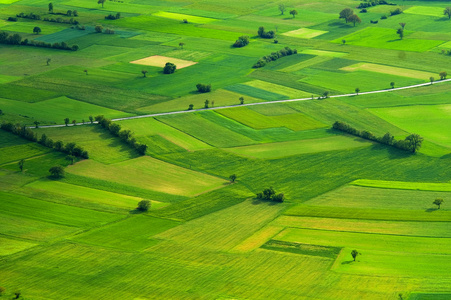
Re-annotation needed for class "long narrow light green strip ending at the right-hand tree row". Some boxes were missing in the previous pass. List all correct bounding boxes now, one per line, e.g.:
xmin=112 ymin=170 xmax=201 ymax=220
xmin=227 ymin=136 xmax=372 ymax=159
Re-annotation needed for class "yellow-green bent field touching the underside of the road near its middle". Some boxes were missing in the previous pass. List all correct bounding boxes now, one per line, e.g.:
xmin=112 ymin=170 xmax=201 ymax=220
xmin=218 ymin=105 xmax=325 ymax=131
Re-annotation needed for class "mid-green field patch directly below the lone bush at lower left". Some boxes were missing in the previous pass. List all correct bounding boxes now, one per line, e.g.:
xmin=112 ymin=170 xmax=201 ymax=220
xmin=72 ymin=216 xmax=179 ymax=251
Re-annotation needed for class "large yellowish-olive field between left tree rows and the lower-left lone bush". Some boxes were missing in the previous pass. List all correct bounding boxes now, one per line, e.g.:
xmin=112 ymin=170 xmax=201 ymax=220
xmin=67 ymin=156 xmax=225 ymax=196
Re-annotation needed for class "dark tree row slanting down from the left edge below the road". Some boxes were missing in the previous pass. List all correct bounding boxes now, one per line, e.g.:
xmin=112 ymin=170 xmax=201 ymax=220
xmin=0 ymin=122 xmax=89 ymax=159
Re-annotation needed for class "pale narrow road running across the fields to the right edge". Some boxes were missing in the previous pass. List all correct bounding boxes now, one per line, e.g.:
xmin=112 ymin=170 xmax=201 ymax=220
xmin=35 ymin=79 xmax=451 ymax=128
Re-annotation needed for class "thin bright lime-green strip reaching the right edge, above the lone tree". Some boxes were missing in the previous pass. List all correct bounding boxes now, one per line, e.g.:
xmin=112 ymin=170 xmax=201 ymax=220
xmin=349 ymin=179 xmax=451 ymax=192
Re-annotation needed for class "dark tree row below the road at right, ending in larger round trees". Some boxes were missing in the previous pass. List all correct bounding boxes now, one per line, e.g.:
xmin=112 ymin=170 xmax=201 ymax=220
xmin=332 ymin=121 xmax=423 ymax=153
